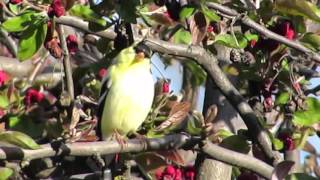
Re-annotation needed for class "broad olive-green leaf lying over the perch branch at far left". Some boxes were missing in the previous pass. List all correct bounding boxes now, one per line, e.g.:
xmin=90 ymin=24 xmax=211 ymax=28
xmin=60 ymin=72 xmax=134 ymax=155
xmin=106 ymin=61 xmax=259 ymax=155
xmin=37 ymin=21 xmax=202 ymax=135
xmin=0 ymin=131 xmax=41 ymax=149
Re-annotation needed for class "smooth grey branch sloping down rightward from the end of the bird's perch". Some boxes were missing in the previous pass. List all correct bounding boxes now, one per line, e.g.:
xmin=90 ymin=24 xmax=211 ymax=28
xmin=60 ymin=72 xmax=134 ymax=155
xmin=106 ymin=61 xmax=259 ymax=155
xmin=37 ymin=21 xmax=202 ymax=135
xmin=201 ymin=141 xmax=273 ymax=179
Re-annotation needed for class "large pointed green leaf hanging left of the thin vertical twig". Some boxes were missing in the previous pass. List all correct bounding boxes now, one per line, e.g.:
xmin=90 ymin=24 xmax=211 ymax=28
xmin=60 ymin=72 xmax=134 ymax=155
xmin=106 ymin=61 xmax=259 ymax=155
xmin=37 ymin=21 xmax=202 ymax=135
xmin=18 ymin=17 xmax=48 ymax=61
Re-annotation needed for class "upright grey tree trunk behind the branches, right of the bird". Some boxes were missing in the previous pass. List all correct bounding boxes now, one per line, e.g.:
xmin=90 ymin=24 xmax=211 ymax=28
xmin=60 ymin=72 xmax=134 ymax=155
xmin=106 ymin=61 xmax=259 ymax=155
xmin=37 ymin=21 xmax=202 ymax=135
xmin=197 ymin=46 xmax=246 ymax=180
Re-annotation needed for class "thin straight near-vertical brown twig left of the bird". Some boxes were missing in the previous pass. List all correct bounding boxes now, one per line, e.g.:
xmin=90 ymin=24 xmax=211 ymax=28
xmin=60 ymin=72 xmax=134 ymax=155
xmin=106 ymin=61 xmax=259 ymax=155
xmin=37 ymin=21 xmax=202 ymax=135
xmin=57 ymin=24 xmax=74 ymax=99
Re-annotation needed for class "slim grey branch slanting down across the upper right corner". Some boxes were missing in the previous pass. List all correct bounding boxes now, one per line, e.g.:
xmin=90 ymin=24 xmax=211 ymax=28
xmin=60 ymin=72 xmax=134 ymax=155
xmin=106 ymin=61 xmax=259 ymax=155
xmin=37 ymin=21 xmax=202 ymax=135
xmin=207 ymin=2 xmax=320 ymax=63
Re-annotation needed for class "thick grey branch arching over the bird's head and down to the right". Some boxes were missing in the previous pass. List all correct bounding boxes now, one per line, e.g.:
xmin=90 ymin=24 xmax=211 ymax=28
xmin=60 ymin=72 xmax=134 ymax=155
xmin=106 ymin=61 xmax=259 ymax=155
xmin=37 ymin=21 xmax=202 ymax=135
xmin=56 ymin=17 xmax=274 ymax=158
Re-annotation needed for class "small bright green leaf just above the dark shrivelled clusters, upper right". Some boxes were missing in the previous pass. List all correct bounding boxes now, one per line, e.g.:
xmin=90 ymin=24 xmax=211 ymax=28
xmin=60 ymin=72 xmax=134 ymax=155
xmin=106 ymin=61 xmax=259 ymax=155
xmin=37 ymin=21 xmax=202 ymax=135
xmin=215 ymin=33 xmax=248 ymax=49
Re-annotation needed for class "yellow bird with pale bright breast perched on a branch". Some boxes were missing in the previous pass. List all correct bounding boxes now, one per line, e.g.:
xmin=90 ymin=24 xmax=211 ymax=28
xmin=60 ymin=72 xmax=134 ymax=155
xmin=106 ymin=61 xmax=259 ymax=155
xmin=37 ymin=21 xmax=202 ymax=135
xmin=101 ymin=46 xmax=154 ymax=140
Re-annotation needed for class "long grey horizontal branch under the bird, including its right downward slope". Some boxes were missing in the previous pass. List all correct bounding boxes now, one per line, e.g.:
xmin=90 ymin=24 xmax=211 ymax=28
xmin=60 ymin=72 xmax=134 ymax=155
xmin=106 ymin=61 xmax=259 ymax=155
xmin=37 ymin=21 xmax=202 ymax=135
xmin=0 ymin=134 xmax=273 ymax=178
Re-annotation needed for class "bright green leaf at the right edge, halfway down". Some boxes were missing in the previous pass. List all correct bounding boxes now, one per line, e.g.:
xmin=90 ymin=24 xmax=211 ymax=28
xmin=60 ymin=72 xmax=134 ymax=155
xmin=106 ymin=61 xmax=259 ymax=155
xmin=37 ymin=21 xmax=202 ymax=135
xmin=293 ymin=97 xmax=320 ymax=126
